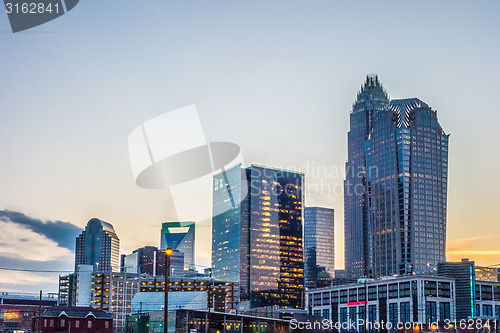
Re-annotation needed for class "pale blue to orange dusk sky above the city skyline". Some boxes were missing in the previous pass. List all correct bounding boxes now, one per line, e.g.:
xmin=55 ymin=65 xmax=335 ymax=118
xmin=0 ymin=0 xmax=500 ymax=291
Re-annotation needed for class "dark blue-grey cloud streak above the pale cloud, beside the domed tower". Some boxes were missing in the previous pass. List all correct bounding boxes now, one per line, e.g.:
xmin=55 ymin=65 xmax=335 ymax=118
xmin=0 ymin=210 xmax=82 ymax=251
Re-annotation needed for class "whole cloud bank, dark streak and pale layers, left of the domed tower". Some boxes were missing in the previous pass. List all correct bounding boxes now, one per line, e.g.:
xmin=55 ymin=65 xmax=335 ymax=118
xmin=0 ymin=210 xmax=81 ymax=292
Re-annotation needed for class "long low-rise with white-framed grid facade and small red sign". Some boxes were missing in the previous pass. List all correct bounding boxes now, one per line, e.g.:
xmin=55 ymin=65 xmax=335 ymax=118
xmin=307 ymin=275 xmax=455 ymax=331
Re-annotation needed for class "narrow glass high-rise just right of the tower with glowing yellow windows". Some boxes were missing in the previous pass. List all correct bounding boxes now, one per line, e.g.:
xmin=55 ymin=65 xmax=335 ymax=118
xmin=304 ymin=207 xmax=335 ymax=288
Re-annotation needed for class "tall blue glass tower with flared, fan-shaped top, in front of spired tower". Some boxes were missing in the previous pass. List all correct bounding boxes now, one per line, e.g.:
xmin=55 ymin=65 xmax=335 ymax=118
xmin=367 ymin=98 xmax=448 ymax=276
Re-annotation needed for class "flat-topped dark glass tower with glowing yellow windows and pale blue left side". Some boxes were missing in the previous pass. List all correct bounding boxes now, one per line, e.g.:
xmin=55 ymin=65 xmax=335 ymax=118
xmin=212 ymin=165 xmax=304 ymax=308
